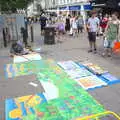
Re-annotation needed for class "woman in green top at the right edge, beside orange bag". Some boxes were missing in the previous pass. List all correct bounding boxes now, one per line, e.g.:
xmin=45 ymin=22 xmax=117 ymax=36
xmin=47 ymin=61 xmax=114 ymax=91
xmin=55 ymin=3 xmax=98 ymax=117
xmin=103 ymin=13 xmax=120 ymax=57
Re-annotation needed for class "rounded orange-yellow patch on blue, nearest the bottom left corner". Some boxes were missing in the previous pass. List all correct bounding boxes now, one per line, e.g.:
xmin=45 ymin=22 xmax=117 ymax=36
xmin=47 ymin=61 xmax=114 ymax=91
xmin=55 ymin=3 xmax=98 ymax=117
xmin=9 ymin=109 xmax=22 ymax=119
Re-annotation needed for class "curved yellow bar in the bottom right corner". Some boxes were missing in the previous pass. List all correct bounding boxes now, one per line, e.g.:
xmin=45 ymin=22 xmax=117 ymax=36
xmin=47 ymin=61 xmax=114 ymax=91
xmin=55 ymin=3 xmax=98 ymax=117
xmin=76 ymin=111 xmax=120 ymax=120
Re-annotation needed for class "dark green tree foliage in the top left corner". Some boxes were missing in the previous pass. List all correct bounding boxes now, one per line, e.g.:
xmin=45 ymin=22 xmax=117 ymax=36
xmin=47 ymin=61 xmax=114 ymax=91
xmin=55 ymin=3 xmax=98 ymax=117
xmin=0 ymin=0 xmax=33 ymax=12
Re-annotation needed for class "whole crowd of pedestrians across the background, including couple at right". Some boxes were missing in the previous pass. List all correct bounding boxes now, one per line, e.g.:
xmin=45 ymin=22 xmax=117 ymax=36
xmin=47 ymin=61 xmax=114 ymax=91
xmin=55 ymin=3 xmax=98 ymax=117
xmin=10 ymin=11 xmax=120 ymax=57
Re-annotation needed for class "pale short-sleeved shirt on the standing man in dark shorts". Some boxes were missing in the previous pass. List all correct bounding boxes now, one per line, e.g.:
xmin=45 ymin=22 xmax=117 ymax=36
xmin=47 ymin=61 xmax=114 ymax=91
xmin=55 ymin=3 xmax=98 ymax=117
xmin=88 ymin=17 xmax=100 ymax=32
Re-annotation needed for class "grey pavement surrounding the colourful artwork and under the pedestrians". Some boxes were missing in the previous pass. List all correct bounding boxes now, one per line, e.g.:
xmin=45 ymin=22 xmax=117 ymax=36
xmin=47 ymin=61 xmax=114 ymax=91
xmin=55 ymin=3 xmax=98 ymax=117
xmin=0 ymin=24 xmax=120 ymax=120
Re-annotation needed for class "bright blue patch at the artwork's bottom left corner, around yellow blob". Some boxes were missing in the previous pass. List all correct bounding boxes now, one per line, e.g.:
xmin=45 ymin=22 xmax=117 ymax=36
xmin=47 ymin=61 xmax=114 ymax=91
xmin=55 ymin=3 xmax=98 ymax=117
xmin=5 ymin=99 xmax=19 ymax=120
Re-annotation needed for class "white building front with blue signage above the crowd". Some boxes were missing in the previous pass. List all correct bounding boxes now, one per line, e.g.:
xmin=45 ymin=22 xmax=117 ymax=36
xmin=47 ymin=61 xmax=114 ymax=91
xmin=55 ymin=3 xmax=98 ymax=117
xmin=28 ymin=0 xmax=91 ymax=16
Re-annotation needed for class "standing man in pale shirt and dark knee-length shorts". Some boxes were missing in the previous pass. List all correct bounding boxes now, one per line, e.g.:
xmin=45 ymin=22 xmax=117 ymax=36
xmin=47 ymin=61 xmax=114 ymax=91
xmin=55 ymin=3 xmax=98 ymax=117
xmin=87 ymin=11 xmax=100 ymax=53
